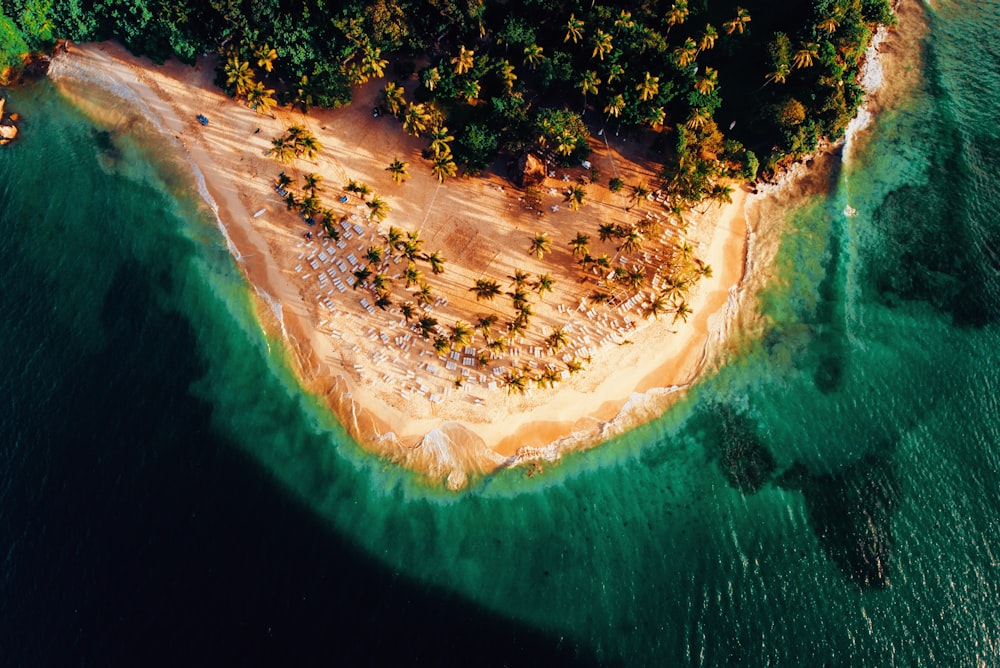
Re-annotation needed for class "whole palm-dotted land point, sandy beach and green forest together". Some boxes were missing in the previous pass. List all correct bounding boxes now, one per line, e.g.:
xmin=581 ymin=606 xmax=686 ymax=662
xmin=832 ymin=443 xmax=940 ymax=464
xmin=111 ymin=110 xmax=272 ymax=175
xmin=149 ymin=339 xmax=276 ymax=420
xmin=0 ymin=0 xmax=893 ymax=488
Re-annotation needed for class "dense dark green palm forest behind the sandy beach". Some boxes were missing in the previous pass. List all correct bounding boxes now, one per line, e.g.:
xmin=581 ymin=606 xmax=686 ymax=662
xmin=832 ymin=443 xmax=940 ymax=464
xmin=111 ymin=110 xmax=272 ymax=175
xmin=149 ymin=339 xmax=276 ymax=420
xmin=0 ymin=0 xmax=893 ymax=198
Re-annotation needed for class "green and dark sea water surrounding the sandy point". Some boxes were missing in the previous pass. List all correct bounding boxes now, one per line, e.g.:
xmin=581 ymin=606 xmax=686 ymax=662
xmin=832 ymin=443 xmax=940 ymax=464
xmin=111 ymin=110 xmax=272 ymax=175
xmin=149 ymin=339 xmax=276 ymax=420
xmin=0 ymin=1 xmax=1000 ymax=666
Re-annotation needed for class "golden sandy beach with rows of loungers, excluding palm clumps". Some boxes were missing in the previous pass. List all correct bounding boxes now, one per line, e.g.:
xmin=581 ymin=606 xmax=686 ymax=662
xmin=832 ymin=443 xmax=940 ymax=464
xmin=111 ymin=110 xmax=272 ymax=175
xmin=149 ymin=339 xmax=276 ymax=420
xmin=50 ymin=43 xmax=749 ymax=487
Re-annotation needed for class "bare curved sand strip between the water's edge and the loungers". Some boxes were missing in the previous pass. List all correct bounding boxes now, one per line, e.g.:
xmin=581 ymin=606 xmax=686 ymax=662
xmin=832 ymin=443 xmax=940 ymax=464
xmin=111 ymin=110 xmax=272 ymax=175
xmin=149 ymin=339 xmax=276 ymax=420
xmin=50 ymin=43 xmax=753 ymax=488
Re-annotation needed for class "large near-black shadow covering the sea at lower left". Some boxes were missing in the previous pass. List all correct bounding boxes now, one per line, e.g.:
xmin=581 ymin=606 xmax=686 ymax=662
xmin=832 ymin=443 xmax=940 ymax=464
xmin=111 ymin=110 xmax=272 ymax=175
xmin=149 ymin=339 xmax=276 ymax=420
xmin=0 ymin=264 xmax=593 ymax=666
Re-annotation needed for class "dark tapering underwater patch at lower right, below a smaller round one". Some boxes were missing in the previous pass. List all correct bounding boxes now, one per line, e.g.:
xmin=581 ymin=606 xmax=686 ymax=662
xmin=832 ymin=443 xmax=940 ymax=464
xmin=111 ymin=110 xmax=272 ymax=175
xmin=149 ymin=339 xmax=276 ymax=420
xmin=778 ymin=454 xmax=900 ymax=589
